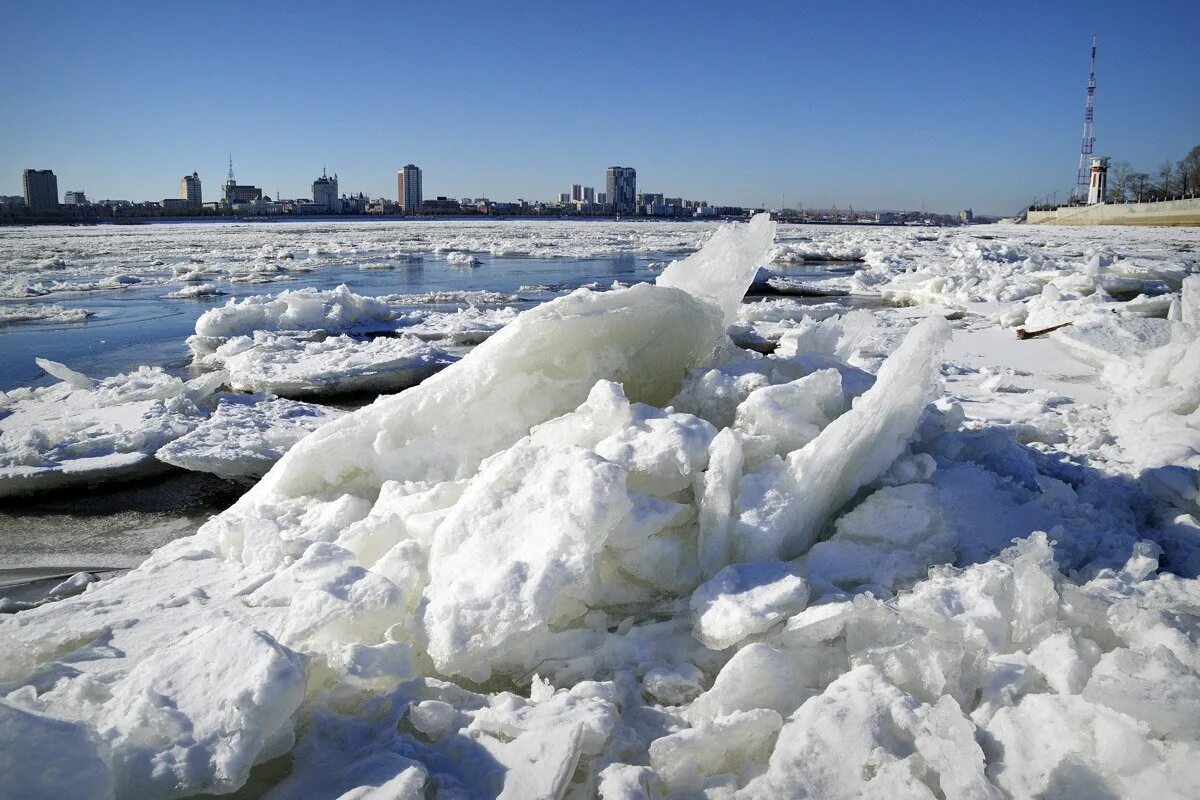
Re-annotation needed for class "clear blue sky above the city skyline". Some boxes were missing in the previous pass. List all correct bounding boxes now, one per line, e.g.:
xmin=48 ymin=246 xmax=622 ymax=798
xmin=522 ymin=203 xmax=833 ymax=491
xmin=0 ymin=0 xmax=1200 ymax=212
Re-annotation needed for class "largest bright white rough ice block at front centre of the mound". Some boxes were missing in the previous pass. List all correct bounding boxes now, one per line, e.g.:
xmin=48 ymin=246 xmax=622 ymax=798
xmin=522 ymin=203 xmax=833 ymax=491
xmin=425 ymin=443 xmax=632 ymax=680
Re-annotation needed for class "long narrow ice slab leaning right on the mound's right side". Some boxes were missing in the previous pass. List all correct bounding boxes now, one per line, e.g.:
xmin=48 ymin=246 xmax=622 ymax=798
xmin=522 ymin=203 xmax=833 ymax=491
xmin=734 ymin=318 xmax=949 ymax=560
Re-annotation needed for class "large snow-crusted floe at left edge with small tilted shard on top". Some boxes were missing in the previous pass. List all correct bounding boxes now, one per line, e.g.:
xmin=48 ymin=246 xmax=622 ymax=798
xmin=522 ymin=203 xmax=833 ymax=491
xmin=0 ymin=359 xmax=222 ymax=497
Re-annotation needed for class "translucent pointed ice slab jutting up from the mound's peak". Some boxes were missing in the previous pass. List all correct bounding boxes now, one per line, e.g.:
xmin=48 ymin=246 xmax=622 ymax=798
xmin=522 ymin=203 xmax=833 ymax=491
xmin=656 ymin=213 xmax=775 ymax=327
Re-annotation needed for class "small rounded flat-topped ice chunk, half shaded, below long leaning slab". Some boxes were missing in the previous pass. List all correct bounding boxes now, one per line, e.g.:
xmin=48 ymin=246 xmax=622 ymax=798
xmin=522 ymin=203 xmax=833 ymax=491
xmin=691 ymin=561 xmax=809 ymax=650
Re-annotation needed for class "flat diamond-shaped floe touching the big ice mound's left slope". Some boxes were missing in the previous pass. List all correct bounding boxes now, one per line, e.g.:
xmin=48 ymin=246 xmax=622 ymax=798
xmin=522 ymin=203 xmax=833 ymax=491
xmin=155 ymin=395 xmax=343 ymax=480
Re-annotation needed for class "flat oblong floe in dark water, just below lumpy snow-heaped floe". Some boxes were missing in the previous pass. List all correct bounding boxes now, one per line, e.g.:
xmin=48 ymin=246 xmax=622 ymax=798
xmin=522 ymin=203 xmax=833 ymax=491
xmin=218 ymin=332 xmax=455 ymax=397
